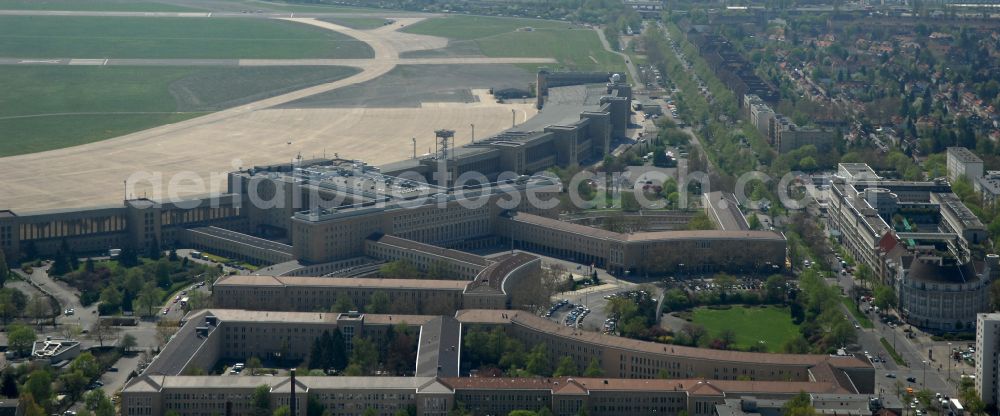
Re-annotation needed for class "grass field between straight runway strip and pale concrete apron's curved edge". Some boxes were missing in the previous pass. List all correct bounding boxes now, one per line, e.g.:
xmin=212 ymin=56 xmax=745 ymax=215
xmin=0 ymin=66 xmax=357 ymax=156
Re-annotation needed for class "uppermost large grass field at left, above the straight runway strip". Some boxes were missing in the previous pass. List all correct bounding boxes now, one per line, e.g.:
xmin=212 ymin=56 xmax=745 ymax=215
xmin=0 ymin=16 xmax=373 ymax=59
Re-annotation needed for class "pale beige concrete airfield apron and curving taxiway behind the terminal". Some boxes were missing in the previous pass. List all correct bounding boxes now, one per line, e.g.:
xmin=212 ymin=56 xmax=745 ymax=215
xmin=0 ymin=17 xmax=554 ymax=213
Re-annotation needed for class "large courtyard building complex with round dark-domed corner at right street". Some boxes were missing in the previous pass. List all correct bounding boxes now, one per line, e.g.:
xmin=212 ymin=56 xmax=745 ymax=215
xmin=828 ymin=164 xmax=998 ymax=331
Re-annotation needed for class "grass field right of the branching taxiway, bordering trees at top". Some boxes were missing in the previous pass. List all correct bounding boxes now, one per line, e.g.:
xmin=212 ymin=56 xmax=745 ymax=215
xmin=404 ymin=16 xmax=625 ymax=71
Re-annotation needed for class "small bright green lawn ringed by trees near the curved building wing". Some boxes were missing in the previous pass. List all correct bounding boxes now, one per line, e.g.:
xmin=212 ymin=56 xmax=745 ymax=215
xmin=694 ymin=306 xmax=800 ymax=352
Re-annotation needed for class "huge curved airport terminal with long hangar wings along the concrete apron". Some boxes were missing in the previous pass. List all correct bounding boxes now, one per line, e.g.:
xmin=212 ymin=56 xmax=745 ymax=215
xmin=0 ymin=71 xmax=785 ymax=279
